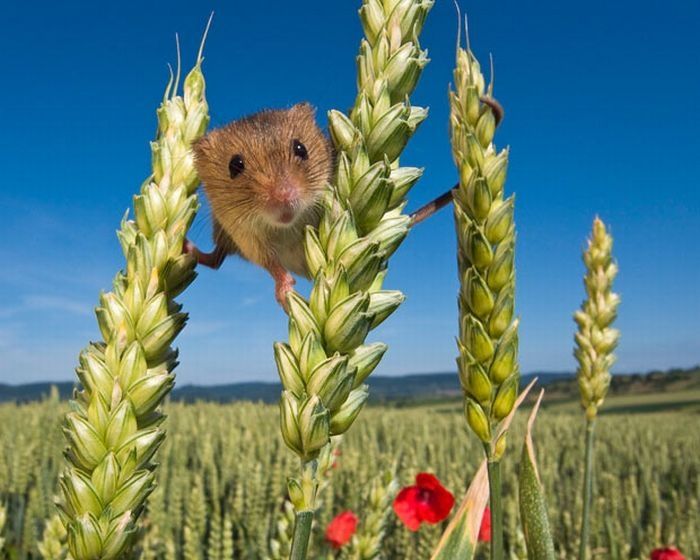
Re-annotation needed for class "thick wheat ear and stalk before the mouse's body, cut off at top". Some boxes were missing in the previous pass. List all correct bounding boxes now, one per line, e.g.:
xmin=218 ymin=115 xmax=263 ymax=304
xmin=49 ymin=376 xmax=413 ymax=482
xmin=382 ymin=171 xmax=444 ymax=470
xmin=275 ymin=0 xmax=433 ymax=558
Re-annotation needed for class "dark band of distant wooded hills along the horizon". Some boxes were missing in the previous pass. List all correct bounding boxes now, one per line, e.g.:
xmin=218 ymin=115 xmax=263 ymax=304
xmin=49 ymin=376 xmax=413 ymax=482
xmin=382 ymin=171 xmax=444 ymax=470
xmin=0 ymin=366 xmax=700 ymax=404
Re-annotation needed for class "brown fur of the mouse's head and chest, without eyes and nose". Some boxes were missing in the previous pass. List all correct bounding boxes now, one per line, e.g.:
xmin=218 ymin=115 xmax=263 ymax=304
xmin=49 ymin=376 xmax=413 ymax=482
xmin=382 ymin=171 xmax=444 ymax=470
xmin=194 ymin=103 xmax=333 ymax=276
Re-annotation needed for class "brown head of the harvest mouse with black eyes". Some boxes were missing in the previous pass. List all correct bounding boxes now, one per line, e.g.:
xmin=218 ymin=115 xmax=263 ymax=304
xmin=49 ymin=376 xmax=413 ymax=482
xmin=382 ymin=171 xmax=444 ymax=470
xmin=194 ymin=103 xmax=333 ymax=227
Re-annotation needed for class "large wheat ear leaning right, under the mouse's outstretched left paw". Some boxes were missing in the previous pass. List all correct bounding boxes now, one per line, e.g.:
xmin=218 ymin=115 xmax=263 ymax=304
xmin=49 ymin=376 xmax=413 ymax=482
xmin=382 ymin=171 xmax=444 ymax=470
xmin=58 ymin=20 xmax=211 ymax=560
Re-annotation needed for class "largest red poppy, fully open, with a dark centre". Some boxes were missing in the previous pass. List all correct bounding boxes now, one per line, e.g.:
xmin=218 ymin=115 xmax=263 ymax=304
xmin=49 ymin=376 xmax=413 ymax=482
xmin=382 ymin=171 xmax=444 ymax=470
xmin=394 ymin=473 xmax=455 ymax=531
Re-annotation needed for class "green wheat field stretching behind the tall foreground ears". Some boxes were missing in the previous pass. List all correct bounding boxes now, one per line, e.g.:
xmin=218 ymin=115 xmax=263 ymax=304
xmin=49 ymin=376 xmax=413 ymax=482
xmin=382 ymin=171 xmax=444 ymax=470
xmin=0 ymin=394 xmax=700 ymax=560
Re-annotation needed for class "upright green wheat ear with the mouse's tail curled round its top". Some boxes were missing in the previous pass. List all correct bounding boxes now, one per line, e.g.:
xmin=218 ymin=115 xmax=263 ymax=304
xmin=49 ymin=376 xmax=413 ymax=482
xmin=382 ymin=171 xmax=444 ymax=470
xmin=450 ymin=44 xmax=520 ymax=458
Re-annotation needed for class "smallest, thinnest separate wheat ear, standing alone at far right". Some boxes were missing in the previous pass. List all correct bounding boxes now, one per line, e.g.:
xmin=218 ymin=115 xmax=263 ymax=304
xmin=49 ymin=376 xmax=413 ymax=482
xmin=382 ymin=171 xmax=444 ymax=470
xmin=574 ymin=218 xmax=620 ymax=420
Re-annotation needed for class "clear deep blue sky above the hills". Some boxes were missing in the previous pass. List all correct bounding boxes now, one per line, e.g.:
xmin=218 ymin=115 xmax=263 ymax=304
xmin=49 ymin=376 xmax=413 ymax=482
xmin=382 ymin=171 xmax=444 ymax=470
xmin=0 ymin=0 xmax=700 ymax=383
